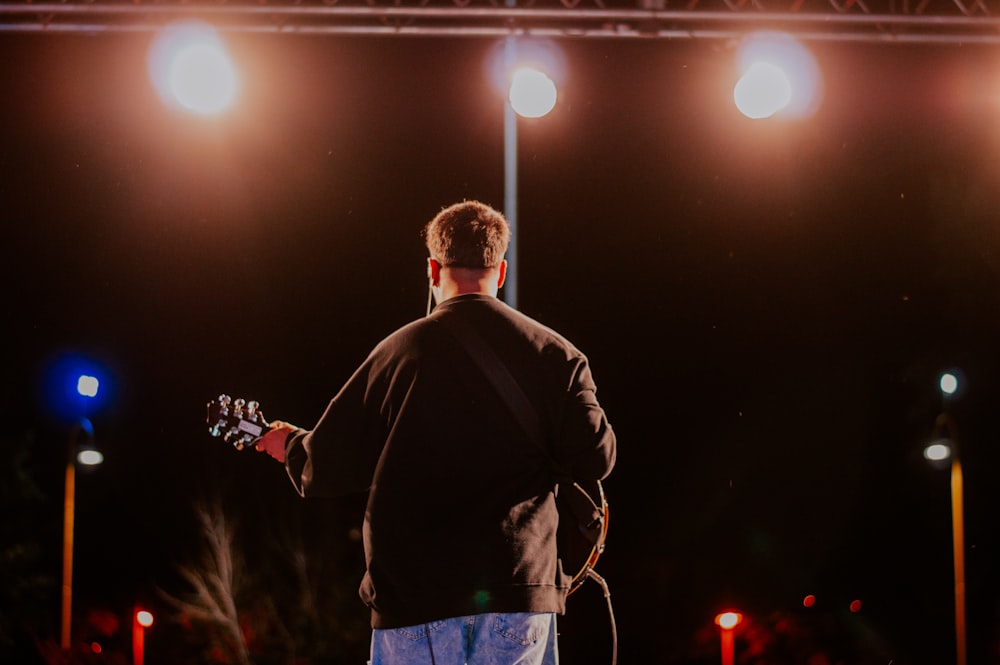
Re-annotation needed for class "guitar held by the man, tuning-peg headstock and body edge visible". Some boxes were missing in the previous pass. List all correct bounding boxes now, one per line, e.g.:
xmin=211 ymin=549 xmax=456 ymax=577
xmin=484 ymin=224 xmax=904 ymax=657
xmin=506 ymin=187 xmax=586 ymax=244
xmin=205 ymin=394 xmax=608 ymax=594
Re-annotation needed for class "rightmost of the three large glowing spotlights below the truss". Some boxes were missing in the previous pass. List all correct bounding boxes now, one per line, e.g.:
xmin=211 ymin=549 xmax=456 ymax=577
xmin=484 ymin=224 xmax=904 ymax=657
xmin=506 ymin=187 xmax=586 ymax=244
xmin=733 ymin=32 xmax=823 ymax=118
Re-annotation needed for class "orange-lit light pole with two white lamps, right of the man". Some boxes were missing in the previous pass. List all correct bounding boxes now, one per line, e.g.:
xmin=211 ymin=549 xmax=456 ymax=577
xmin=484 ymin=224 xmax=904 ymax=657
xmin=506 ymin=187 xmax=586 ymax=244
xmin=924 ymin=374 xmax=966 ymax=665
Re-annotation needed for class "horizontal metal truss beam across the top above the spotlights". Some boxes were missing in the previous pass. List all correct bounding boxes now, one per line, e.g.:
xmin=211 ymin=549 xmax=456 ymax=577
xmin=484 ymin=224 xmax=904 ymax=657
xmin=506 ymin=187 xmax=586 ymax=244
xmin=0 ymin=0 xmax=1000 ymax=44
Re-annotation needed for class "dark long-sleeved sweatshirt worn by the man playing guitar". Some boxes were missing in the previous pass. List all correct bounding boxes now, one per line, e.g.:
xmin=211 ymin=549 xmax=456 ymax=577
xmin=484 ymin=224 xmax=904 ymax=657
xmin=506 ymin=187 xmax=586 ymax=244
xmin=286 ymin=295 xmax=616 ymax=628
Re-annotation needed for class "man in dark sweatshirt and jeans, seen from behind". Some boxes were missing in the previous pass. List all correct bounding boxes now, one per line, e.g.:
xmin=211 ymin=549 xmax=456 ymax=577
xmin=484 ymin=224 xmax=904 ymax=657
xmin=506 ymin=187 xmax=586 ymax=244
xmin=257 ymin=201 xmax=616 ymax=665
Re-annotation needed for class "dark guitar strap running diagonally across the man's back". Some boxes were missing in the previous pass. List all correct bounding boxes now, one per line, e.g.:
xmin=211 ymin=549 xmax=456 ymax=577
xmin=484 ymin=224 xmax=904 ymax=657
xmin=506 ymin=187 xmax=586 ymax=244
xmin=434 ymin=315 xmax=604 ymax=543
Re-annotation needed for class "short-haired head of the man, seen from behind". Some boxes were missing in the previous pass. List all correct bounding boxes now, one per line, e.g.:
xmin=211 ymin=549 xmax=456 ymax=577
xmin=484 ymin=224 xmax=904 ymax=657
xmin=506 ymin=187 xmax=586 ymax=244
xmin=423 ymin=201 xmax=510 ymax=302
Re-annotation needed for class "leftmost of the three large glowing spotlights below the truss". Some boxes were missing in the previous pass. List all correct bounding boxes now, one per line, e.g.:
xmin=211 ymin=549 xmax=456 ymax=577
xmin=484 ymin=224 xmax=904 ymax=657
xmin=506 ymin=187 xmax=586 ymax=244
xmin=149 ymin=21 xmax=237 ymax=115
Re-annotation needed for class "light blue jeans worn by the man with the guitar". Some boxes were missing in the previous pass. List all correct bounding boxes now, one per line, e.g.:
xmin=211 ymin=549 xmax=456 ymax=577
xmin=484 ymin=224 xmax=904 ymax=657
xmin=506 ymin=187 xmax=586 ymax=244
xmin=369 ymin=612 xmax=559 ymax=665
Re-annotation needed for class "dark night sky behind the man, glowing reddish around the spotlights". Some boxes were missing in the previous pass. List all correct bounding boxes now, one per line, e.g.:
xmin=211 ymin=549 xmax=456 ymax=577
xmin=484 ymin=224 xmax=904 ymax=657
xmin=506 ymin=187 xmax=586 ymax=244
xmin=0 ymin=27 xmax=1000 ymax=665
